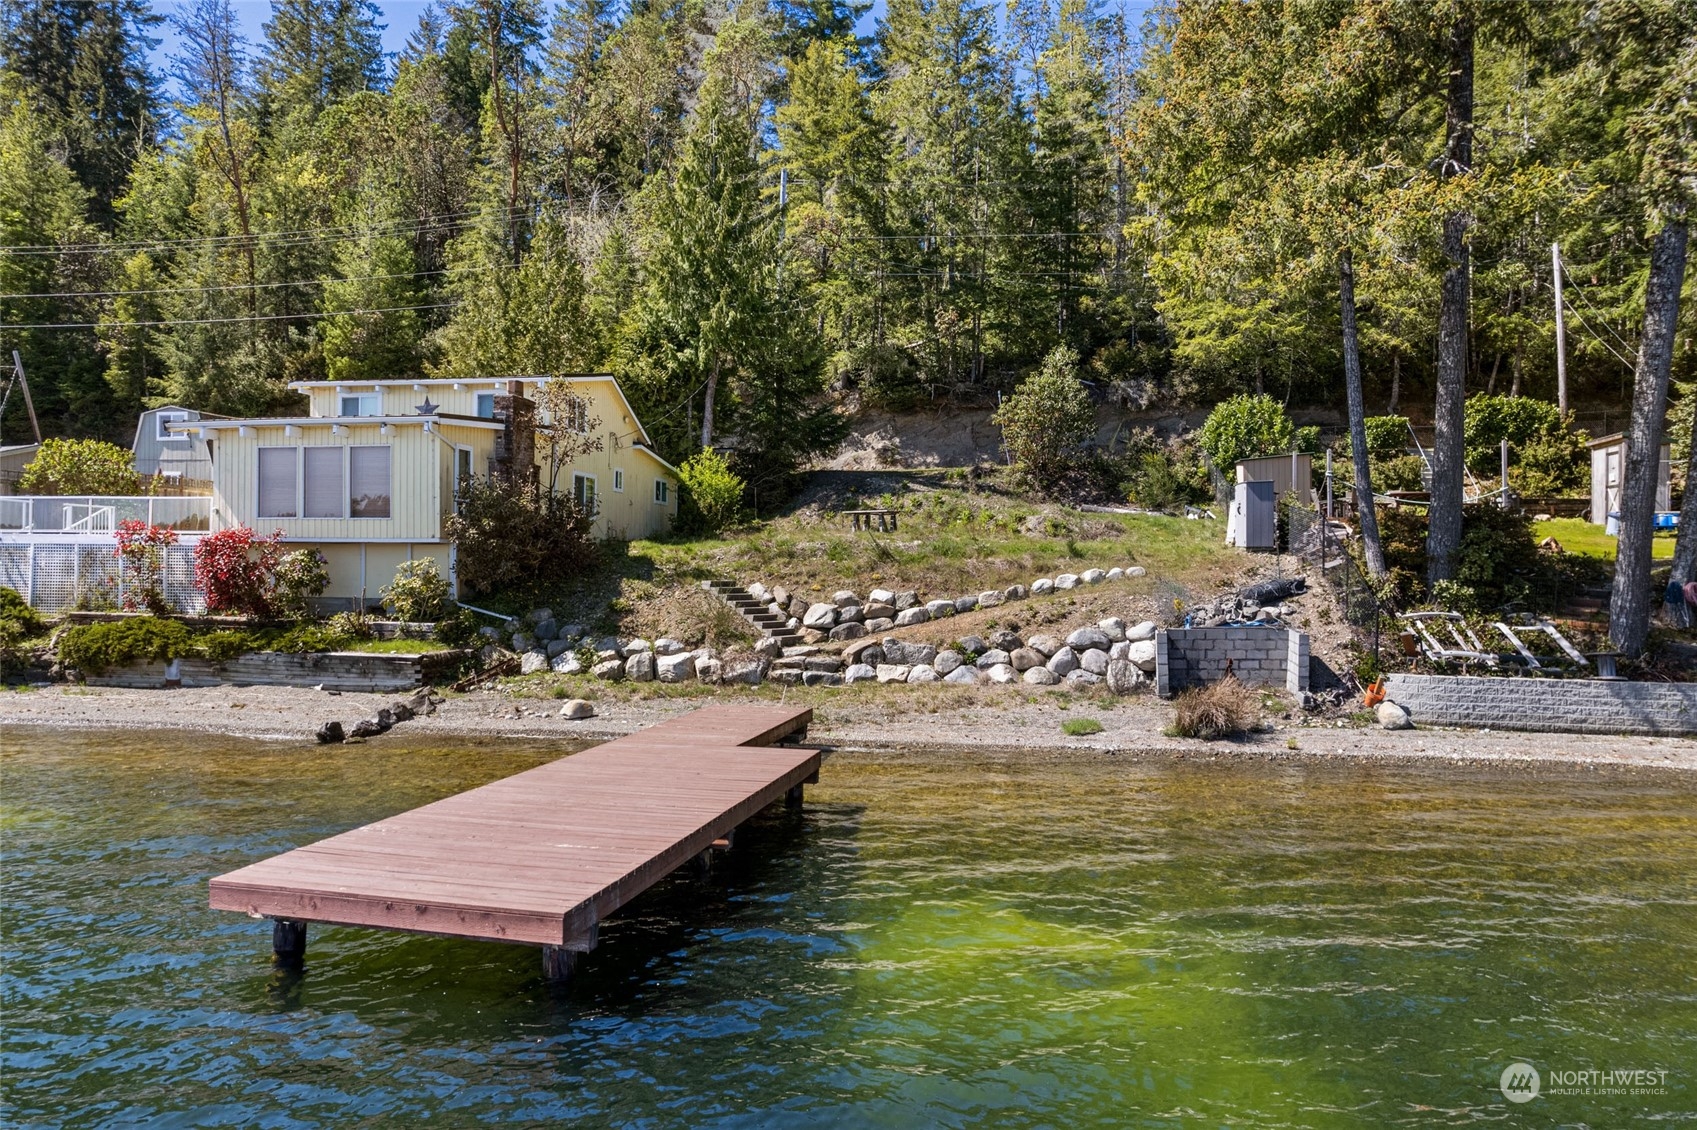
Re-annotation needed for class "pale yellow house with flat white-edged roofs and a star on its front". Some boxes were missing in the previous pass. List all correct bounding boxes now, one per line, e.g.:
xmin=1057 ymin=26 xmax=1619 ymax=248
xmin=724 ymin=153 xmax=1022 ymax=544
xmin=171 ymin=373 xmax=677 ymax=604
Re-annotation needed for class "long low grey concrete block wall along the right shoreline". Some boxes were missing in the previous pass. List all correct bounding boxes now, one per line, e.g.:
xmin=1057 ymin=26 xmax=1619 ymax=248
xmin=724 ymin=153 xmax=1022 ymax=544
xmin=1385 ymin=675 xmax=1697 ymax=735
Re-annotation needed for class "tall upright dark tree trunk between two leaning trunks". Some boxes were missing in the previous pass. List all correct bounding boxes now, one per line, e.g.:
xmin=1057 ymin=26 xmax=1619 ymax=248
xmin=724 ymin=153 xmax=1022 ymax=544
xmin=1425 ymin=8 xmax=1473 ymax=582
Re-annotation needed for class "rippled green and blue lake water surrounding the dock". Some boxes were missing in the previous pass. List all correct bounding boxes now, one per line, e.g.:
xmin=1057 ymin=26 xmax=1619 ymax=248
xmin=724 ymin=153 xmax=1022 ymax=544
xmin=0 ymin=730 xmax=1697 ymax=1128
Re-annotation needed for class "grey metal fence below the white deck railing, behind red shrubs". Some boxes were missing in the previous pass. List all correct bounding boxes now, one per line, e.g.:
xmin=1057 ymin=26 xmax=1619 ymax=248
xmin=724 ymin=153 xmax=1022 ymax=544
xmin=0 ymin=541 xmax=205 ymax=614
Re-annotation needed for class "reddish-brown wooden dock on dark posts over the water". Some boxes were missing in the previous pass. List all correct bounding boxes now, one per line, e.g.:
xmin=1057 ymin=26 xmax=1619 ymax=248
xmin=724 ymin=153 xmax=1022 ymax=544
xmin=210 ymin=706 xmax=820 ymax=979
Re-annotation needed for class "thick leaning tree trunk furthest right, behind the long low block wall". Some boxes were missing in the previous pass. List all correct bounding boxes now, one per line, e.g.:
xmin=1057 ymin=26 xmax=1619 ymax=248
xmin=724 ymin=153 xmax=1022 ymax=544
xmin=1609 ymin=209 xmax=1687 ymax=658
